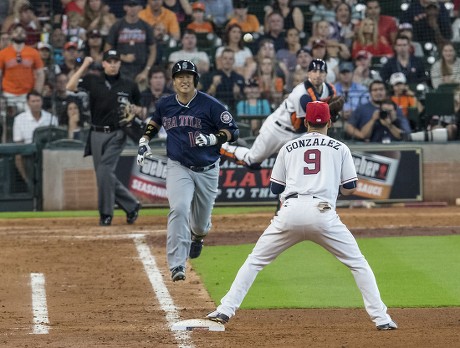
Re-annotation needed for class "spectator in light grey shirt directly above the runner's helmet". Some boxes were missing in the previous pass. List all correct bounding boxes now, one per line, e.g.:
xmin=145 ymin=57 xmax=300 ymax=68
xmin=168 ymin=29 xmax=210 ymax=74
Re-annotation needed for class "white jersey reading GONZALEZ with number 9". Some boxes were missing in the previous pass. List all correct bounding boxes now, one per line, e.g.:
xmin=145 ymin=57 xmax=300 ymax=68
xmin=270 ymin=132 xmax=358 ymax=207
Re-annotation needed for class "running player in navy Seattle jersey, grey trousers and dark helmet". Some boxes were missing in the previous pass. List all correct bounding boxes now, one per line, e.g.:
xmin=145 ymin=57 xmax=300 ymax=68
xmin=137 ymin=60 xmax=239 ymax=281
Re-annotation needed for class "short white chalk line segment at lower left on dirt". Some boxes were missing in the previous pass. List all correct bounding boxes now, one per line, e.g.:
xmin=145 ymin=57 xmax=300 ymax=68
xmin=30 ymin=273 xmax=49 ymax=335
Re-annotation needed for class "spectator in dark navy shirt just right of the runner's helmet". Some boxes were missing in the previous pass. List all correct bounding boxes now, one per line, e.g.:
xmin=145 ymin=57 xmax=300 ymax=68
xmin=199 ymin=48 xmax=244 ymax=114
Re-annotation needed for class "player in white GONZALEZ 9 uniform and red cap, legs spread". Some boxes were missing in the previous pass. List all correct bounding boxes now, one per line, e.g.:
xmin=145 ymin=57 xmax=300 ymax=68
xmin=206 ymin=101 xmax=397 ymax=330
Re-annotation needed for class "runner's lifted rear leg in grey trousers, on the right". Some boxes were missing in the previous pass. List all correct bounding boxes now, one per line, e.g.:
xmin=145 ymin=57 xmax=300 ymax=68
xmin=189 ymin=162 xmax=219 ymax=258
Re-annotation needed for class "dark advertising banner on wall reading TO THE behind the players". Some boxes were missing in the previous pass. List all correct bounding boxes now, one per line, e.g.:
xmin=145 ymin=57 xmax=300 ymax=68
xmin=117 ymin=149 xmax=422 ymax=205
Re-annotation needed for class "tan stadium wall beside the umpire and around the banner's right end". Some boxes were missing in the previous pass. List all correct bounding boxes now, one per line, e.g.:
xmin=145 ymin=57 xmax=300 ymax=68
xmin=43 ymin=142 xmax=460 ymax=211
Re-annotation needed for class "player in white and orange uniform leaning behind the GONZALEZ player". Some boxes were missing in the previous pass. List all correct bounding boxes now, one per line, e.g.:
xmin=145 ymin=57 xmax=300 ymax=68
xmin=221 ymin=59 xmax=343 ymax=169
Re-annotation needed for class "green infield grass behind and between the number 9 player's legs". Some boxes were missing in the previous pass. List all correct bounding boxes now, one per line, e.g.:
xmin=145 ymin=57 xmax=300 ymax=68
xmin=192 ymin=235 xmax=460 ymax=309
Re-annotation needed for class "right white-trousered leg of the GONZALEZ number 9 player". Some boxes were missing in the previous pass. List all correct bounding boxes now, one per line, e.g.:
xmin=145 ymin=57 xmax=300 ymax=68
xmin=312 ymin=211 xmax=391 ymax=326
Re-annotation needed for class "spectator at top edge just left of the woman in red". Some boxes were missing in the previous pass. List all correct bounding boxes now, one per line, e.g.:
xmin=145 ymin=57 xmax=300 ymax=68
xmin=330 ymin=2 xmax=356 ymax=51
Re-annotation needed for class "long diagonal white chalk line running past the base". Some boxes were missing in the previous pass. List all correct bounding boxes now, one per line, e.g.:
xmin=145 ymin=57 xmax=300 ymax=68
xmin=133 ymin=234 xmax=194 ymax=348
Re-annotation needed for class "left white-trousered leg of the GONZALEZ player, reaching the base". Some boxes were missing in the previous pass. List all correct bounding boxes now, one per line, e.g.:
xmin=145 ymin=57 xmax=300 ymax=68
xmin=208 ymin=207 xmax=304 ymax=318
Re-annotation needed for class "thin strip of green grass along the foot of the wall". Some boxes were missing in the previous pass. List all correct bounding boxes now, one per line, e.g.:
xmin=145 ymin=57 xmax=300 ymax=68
xmin=0 ymin=206 xmax=275 ymax=219
